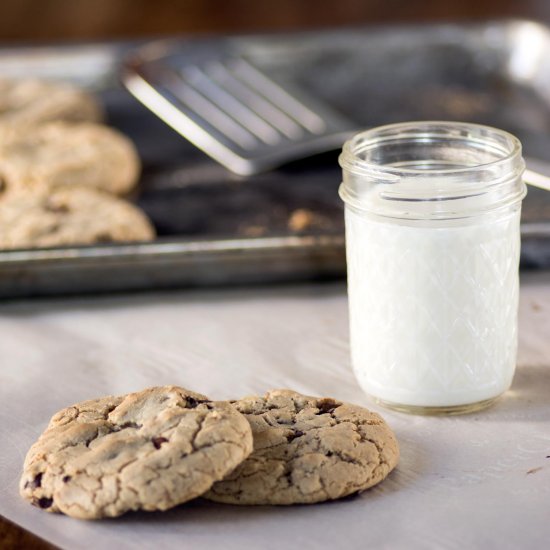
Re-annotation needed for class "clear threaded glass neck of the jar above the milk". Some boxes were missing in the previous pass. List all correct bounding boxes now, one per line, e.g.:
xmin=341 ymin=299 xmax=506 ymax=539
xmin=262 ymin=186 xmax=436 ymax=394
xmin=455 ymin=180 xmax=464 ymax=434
xmin=339 ymin=121 xmax=526 ymax=219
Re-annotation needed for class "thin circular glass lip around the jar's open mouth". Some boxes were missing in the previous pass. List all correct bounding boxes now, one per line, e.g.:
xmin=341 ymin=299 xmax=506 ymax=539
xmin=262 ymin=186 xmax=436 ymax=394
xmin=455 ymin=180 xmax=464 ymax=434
xmin=338 ymin=120 xmax=521 ymax=180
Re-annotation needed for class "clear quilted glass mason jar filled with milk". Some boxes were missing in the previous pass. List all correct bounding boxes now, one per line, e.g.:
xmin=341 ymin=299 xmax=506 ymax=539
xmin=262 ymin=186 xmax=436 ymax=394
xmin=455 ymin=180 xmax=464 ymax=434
xmin=340 ymin=122 xmax=526 ymax=413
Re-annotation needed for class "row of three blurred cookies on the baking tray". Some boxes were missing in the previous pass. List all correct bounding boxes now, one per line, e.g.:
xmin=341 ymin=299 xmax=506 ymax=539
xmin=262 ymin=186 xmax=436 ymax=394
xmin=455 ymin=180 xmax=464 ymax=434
xmin=0 ymin=80 xmax=155 ymax=249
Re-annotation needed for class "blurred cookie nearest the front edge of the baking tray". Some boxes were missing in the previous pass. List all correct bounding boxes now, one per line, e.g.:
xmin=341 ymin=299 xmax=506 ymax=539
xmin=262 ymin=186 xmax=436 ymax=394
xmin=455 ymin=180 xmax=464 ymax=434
xmin=0 ymin=187 xmax=155 ymax=249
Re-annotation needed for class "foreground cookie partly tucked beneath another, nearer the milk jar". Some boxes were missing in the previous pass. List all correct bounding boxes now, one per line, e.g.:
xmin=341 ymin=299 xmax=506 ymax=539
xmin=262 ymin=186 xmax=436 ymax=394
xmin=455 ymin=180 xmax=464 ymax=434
xmin=207 ymin=390 xmax=399 ymax=504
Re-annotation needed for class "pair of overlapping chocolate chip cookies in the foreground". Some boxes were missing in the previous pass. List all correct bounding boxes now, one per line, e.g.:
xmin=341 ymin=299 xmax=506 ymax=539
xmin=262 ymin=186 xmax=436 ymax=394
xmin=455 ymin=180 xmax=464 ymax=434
xmin=20 ymin=386 xmax=399 ymax=519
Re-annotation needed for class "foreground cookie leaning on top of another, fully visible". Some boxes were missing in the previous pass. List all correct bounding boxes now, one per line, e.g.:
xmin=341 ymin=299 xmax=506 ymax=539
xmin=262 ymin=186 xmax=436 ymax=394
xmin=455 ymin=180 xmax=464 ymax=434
xmin=20 ymin=386 xmax=252 ymax=519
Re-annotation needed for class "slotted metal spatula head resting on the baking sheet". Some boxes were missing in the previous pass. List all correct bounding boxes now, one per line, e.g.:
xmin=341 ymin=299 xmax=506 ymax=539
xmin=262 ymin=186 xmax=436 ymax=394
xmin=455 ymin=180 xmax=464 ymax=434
xmin=124 ymin=49 xmax=355 ymax=175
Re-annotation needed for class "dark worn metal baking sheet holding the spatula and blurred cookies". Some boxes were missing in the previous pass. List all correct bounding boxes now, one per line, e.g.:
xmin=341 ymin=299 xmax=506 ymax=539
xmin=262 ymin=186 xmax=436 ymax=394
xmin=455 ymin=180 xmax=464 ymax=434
xmin=0 ymin=21 xmax=550 ymax=298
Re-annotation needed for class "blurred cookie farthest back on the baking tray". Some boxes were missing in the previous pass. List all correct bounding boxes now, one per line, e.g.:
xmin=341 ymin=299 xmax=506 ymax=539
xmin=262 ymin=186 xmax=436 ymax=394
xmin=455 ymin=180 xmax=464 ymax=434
xmin=0 ymin=78 xmax=104 ymax=143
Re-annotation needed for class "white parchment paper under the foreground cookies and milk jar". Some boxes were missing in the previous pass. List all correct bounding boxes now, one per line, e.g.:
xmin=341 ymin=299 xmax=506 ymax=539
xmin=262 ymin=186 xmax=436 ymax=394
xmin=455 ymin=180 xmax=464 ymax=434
xmin=0 ymin=273 xmax=550 ymax=550
